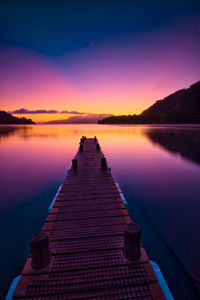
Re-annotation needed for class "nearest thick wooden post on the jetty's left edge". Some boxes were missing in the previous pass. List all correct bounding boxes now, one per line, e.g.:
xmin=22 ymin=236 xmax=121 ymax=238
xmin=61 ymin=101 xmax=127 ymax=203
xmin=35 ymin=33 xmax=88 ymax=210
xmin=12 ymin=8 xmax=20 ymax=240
xmin=30 ymin=231 xmax=51 ymax=269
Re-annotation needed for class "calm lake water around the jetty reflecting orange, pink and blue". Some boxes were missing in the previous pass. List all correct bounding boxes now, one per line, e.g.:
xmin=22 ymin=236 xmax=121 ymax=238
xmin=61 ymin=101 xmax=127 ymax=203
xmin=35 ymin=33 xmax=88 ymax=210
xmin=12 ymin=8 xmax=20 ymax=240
xmin=0 ymin=125 xmax=200 ymax=299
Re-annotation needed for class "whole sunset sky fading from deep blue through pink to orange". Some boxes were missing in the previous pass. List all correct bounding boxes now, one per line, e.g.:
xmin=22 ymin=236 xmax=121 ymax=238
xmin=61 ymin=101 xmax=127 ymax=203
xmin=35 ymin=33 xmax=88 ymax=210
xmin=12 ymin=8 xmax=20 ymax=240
xmin=0 ymin=0 xmax=200 ymax=122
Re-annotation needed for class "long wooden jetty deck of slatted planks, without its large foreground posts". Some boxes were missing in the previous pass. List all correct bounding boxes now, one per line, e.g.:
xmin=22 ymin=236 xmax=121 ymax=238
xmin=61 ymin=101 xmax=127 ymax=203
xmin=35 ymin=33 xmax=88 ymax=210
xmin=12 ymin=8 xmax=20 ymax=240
xmin=13 ymin=139 xmax=165 ymax=300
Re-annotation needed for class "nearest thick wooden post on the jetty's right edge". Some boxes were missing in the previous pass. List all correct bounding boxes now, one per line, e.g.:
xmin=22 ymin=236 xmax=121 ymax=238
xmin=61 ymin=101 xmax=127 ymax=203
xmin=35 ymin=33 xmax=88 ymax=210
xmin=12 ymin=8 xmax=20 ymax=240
xmin=123 ymin=222 xmax=141 ymax=260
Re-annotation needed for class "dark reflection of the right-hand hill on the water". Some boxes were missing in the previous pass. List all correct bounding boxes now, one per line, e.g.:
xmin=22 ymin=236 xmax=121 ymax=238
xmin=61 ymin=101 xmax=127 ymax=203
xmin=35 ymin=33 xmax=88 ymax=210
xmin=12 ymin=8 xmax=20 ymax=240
xmin=145 ymin=128 xmax=200 ymax=164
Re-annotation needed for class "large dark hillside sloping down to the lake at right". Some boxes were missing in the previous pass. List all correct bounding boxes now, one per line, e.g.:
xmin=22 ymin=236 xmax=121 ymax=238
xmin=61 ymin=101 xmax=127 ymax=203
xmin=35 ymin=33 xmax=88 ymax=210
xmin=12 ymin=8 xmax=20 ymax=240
xmin=98 ymin=81 xmax=200 ymax=124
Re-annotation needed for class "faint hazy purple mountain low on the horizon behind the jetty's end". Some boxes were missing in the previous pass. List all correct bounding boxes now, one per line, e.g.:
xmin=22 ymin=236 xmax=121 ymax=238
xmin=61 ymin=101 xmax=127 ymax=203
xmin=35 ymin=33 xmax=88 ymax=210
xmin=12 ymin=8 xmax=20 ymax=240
xmin=45 ymin=114 xmax=112 ymax=124
